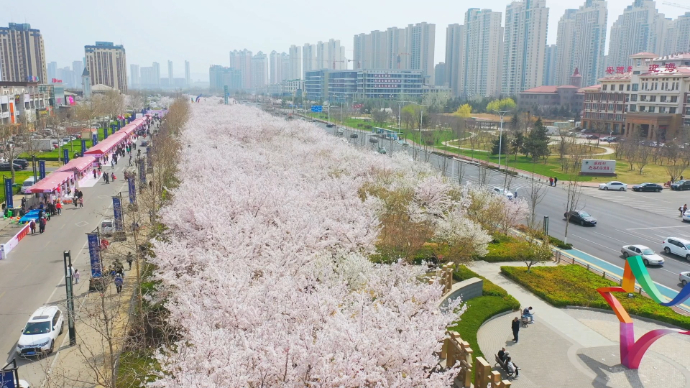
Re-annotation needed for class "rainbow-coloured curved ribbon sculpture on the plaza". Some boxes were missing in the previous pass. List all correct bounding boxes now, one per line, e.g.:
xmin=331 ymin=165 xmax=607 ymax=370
xmin=597 ymin=256 xmax=690 ymax=369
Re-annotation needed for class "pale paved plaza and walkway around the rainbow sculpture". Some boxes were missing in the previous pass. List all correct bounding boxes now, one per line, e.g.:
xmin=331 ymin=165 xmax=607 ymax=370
xmin=470 ymin=261 xmax=690 ymax=388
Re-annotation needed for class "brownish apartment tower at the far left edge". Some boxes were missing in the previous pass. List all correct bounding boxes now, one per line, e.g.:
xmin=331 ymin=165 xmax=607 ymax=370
xmin=0 ymin=23 xmax=47 ymax=82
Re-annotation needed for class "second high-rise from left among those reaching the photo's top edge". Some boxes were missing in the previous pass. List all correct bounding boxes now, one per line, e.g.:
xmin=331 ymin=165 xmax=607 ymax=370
xmin=554 ymin=0 xmax=608 ymax=85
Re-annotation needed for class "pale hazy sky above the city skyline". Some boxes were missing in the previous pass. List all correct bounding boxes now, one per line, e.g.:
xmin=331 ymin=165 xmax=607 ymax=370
xmin=0 ymin=0 xmax=690 ymax=80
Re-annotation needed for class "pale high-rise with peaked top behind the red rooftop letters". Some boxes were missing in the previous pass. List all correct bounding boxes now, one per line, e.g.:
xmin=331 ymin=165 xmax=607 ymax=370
xmin=606 ymin=0 xmax=668 ymax=68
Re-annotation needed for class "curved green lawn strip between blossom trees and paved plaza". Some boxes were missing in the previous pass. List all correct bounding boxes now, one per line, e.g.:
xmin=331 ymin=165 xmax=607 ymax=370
xmin=448 ymin=265 xmax=520 ymax=368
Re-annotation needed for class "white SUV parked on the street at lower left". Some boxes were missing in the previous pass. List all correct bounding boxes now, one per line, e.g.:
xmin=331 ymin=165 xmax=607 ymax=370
xmin=17 ymin=306 xmax=64 ymax=357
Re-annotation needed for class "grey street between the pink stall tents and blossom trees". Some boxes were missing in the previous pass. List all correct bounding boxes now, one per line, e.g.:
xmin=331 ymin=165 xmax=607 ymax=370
xmin=0 ymin=139 xmax=142 ymax=386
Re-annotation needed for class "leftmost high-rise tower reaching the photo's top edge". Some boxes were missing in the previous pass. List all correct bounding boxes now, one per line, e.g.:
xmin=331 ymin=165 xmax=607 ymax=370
xmin=501 ymin=0 xmax=549 ymax=96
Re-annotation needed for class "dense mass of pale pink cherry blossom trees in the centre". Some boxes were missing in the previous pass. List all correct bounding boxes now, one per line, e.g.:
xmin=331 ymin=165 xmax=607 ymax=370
xmin=152 ymin=102 xmax=522 ymax=387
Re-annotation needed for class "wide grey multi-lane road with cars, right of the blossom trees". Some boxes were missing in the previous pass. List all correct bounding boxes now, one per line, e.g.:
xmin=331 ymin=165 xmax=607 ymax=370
xmin=319 ymin=119 xmax=690 ymax=290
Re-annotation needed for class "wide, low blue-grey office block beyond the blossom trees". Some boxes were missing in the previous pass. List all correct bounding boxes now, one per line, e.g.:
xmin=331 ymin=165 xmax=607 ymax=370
xmin=304 ymin=69 xmax=427 ymax=102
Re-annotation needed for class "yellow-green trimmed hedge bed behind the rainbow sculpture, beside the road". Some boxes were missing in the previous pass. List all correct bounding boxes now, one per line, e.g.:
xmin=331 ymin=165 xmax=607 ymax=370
xmin=501 ymin=264 xmax=690 ymax=329
